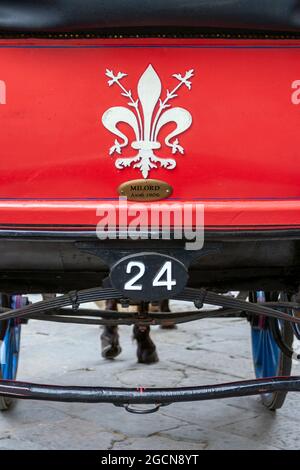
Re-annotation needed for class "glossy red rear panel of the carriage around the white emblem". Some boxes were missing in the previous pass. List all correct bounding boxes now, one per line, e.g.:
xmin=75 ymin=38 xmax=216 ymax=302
xmin=0 ymin=39 xmax=300 ymax=228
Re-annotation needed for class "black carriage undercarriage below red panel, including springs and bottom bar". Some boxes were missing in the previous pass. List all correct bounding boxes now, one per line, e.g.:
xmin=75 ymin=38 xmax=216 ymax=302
xmin=0 ymin=230 xmax=300 ymax=413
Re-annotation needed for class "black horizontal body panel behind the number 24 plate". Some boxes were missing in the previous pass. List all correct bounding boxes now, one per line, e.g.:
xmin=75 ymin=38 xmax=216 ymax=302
xmin=0 ymin=228 xmax=300 ymax=293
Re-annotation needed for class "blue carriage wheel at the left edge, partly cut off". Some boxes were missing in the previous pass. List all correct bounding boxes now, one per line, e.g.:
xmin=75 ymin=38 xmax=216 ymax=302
xmin=0 ymin=295 xmax=27 ymax=411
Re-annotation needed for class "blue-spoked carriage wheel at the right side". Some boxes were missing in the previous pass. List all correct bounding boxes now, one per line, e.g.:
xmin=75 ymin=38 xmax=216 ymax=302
xmin=249 ymin=291 xmax=294 ymax=410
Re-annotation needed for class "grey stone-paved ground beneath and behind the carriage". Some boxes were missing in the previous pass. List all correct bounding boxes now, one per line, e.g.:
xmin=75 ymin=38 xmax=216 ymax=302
xmin=0 ymin=298 xmax=300 ymax=450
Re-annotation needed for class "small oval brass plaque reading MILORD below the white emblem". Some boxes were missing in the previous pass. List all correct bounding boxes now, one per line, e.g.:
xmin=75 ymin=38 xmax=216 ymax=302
xmin=118 ymin=179 xmax=173 ymax=202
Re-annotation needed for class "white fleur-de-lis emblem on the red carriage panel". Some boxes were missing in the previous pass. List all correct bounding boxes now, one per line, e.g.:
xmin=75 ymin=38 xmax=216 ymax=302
xmin=102 ymin=65 xmax=194 ymax=178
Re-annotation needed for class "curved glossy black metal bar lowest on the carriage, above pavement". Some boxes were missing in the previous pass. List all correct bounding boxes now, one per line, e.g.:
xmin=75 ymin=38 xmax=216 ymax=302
xmin=0 ymin=376 xmax=300 ymax=413
